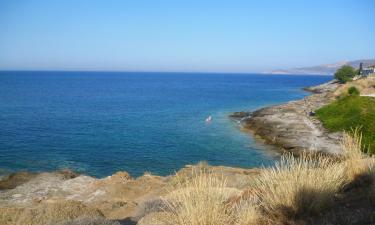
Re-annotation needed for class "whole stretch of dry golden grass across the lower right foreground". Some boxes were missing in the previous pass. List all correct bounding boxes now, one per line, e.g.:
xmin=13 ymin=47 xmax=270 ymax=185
xmin=139 ymin=133 xmax=375 ymax=225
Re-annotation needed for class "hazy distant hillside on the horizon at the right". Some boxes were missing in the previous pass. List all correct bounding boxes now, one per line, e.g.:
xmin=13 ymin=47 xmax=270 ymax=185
xmin=266 ymin=59 xmax=375 ymax=75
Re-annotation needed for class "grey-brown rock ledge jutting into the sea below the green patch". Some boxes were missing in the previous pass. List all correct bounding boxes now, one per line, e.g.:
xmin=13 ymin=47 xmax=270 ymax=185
xmin=229 ymin=81 xmax=342 ymax=155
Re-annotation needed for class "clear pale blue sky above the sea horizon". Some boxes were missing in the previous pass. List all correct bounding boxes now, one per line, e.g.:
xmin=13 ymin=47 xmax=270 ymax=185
xmin=0 ymin=0 xmax=375 ymax=72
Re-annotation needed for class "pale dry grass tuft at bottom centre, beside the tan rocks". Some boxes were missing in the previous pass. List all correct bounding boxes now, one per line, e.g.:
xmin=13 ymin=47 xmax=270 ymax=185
xmin=161 ymin=171 xmax=240 ymax=225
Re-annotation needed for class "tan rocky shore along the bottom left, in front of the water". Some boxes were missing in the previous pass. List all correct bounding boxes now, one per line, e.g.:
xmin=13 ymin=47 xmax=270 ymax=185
xmin=0 ymin=163 xmax=261 ymax=225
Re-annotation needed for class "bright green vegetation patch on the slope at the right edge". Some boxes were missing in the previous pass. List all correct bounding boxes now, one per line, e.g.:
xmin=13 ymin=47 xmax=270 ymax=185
xmin=316 ymin=96 xmax=375 ymax=154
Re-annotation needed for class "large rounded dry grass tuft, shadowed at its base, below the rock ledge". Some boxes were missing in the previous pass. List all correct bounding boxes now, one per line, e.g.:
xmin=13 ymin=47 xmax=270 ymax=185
xmin=257 ymin=153 xmax=345 ymax=219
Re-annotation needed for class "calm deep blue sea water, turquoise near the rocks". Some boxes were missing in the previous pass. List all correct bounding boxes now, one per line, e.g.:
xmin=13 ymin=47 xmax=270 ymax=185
xmin=0 ymin=72 xmax=330 ymax=177
